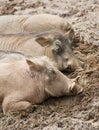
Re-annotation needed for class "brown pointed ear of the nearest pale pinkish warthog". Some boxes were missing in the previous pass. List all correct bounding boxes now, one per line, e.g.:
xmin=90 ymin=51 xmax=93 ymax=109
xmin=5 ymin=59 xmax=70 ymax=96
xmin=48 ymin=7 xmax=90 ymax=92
xmin=26 ymin=59 xmax=44 ymax=71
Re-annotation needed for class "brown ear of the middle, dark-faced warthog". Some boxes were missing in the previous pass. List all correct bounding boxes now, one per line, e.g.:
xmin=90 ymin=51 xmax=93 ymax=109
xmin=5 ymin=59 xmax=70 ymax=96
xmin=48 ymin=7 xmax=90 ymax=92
xmin=35 ymin=36 xmax=52 ymax=47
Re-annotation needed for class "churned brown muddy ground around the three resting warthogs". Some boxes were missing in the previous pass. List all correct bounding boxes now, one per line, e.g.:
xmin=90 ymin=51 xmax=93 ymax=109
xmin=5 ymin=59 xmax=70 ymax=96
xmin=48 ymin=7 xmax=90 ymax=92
xmin=0 ymin=0 xmax=99 ymax=130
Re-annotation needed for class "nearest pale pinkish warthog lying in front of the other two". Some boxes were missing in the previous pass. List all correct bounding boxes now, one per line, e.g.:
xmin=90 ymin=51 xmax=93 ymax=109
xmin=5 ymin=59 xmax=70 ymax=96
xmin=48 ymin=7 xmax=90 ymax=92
xmin=0 ymin=53 xmax=83 ymax=114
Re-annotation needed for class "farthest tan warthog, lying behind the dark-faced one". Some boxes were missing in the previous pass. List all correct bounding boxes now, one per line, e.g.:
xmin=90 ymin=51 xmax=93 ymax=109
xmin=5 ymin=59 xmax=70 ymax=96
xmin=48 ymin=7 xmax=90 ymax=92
xmin=0 ymin=14 xmax=74 ymax=46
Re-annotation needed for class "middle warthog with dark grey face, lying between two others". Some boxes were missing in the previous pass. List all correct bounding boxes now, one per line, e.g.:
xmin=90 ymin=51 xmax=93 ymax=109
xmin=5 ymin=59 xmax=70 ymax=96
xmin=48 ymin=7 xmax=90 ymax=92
xmin=0 ymin=31 xmax=81 ymax=71
